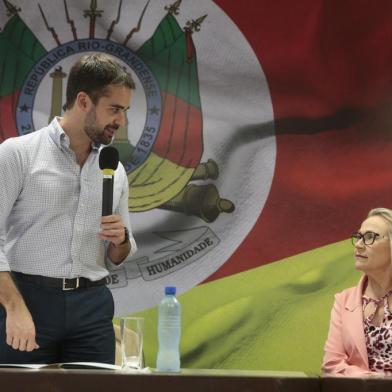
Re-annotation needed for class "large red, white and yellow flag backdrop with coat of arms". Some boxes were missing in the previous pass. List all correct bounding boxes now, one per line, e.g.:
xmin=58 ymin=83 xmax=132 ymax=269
xmin=0 ymin=0 xmax=392 ymax=373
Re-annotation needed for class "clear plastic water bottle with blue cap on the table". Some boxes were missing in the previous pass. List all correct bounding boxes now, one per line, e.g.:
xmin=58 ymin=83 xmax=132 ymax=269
xmin=157 ymin=286 xmax=181 ymax=372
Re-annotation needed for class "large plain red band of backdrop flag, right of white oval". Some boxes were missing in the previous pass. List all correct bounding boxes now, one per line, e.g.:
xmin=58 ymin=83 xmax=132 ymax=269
xmin=209 ymin=0 xmax=392 ymax=279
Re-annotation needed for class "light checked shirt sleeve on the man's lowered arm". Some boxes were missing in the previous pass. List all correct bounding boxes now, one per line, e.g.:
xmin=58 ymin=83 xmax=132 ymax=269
xmin=0 ymin=138 xmax=24 ymax=271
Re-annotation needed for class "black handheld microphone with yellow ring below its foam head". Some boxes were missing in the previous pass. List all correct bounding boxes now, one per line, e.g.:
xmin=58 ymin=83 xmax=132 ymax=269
xmin=99 ymin=146 xmax=120 ymax=216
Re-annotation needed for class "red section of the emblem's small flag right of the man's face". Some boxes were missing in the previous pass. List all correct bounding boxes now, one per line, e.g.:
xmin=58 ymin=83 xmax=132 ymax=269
xmin=153 ymin=94 xmax=203 ymax=168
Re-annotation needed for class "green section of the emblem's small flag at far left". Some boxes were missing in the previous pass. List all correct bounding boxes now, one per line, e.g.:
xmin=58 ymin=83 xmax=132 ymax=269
xmin=0 ymin=15 xmax=47 ymax=97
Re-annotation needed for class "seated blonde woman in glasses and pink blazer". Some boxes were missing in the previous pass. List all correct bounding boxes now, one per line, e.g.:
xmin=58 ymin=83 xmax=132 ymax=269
xmin=322 ymin=208 xmax=392 ymax=376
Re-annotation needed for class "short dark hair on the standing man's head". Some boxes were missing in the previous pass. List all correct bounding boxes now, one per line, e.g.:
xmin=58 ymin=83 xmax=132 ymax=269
xmin=65 ymin=53 xmax=135 ymax=109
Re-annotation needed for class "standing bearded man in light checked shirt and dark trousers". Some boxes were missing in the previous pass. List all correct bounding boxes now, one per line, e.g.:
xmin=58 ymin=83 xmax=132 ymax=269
xmin=0 ymin=54 xmax=136 ymax=363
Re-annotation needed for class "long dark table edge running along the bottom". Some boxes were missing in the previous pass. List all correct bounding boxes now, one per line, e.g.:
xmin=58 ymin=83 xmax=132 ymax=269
xmin=0 ymin=369 xmax=392 ymax=392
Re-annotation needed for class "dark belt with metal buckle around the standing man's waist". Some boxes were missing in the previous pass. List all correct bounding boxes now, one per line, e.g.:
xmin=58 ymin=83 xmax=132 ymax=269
xmin=12 ymin=271 xmax=106 ymax=291
